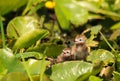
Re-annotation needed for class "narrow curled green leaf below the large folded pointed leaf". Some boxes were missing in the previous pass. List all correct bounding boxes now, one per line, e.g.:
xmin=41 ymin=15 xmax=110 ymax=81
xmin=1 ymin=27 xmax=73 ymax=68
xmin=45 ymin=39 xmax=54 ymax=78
xmin=15 ymin=52 xmax=43 ymax=59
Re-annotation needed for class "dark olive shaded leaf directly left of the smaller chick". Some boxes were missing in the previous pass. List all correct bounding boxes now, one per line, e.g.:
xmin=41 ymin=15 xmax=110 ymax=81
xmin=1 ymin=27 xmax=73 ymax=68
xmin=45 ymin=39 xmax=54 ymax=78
xmin=45 ymin=44 xmax=64 ymax=57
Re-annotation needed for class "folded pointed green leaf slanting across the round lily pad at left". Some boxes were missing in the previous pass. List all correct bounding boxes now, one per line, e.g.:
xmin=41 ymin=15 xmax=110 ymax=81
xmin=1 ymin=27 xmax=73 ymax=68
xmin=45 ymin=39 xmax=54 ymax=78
xmin=13 ymin=29 xmax=49 ymax=50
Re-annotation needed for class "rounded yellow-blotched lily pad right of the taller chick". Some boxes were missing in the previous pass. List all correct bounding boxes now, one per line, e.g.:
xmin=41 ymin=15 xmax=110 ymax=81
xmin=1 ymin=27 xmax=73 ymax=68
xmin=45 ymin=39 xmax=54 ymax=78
xmin=87 ymin=49 xmax=115 ymax=64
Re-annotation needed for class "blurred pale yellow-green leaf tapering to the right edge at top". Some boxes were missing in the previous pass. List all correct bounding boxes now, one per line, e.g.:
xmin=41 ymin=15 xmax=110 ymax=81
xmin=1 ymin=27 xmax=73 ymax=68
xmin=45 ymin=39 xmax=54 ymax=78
xmin=74 ymin=1 xmax=120 ymax=20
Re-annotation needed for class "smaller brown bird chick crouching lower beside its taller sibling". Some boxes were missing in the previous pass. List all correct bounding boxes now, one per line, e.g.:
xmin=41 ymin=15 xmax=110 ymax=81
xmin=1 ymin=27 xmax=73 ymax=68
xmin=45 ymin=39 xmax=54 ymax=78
xmin=56 ymin=48 xmax=72 ymax=63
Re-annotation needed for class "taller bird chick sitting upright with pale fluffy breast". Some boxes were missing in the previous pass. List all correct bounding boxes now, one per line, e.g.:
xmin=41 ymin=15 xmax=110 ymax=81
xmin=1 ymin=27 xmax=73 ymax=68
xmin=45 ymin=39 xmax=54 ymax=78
xmin=71 ymin=34 xmax=89 ymax=60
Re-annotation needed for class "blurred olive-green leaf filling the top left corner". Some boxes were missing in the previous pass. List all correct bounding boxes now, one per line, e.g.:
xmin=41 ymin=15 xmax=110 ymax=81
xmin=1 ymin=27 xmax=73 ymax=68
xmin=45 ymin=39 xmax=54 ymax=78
xmin=0 ymin=0 xmax=28 ymax=15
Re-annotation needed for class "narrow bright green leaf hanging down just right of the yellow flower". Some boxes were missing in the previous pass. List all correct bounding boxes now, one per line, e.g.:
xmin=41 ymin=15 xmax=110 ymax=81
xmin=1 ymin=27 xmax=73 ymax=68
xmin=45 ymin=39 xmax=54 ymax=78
xmin=55 ymin=0 xmax=70 ymax=31
